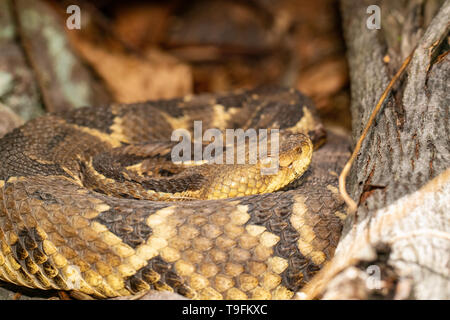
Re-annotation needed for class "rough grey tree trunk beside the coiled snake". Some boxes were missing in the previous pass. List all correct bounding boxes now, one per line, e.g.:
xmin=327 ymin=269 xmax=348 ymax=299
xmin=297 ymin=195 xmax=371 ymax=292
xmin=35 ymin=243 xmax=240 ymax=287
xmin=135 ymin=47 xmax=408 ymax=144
xmin=298 ymin=0 xmax=450 ymax=299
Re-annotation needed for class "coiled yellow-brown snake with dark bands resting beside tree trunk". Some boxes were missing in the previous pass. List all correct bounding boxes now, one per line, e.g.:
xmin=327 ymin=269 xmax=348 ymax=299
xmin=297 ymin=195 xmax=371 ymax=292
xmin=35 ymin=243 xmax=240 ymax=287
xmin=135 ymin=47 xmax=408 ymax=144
xmin=0 ymin=88 xmax=348 ymax=299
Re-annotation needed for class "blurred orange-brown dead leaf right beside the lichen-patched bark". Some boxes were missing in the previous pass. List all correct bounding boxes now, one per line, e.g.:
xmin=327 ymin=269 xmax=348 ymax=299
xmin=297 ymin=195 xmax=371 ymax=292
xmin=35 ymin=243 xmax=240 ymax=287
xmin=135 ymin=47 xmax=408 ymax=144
xmin=71 ymin=32 xmax=192 ymax=103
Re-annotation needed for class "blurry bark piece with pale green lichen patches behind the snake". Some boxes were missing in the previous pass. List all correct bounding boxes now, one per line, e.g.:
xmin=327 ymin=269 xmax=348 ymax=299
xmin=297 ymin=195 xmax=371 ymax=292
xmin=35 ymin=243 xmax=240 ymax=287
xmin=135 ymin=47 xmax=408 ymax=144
xmin=14 ymin=0 xmax=111 ymax=112
